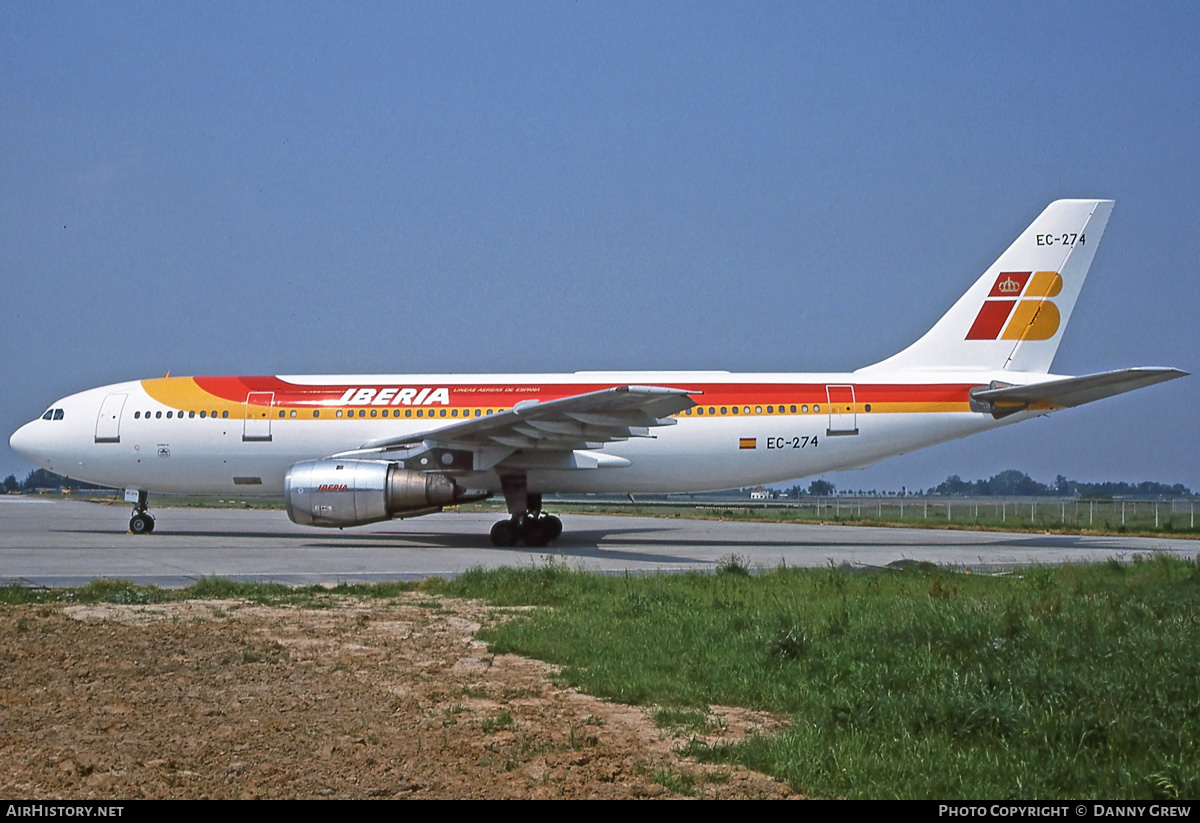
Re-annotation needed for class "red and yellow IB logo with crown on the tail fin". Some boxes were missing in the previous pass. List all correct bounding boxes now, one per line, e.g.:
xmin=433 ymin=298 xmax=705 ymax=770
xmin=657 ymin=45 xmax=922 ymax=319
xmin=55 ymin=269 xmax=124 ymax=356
xmin=966 ymin=271 xmax=1062 ymax=340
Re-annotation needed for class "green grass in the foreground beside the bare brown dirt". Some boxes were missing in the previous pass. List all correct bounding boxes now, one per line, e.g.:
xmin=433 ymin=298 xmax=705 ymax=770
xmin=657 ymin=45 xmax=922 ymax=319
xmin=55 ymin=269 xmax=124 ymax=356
xmin=0 ymin=555 xmax=1200 ymax=799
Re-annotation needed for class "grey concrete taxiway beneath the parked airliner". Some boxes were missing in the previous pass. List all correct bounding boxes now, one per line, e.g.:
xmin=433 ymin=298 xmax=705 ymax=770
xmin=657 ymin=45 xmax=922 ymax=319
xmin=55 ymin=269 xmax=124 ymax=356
xmin=0 ymin=497 xmax=1200 ymax=587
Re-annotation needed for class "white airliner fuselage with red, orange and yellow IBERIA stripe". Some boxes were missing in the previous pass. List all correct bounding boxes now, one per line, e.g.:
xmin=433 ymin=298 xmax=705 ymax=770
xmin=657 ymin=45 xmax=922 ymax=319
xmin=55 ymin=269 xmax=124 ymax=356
xmin=11 ymin=372 xmax=1051 ymax=494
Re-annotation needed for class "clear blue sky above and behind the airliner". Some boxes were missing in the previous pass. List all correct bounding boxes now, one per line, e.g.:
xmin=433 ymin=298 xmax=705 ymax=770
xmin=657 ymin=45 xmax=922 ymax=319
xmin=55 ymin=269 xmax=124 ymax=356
xmin=0 ymin=2 xmax=1200 ymax=489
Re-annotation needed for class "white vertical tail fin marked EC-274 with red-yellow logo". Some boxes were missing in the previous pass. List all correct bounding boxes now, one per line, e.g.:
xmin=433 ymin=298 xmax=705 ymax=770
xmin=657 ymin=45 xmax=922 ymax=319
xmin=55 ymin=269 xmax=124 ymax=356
xmin=859 ymin=200 xmax=1112 ymax=372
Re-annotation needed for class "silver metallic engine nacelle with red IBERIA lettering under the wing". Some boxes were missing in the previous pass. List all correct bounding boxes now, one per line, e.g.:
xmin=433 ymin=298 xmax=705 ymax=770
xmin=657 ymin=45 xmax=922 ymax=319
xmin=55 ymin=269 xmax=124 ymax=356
xmin=283 ymin=459 xmax=460 ymax=528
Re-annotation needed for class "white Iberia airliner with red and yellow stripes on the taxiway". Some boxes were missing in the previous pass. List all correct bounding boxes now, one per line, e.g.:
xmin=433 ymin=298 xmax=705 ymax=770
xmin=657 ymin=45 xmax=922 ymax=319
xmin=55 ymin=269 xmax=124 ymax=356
xmin=10 ymin=199 xmax=1186 ymax=546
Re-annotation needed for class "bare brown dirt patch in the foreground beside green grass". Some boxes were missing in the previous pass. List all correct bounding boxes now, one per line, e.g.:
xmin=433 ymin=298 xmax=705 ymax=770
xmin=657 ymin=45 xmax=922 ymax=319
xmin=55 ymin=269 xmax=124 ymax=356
xmin=0 ymin=595 xmax=791 ymax=799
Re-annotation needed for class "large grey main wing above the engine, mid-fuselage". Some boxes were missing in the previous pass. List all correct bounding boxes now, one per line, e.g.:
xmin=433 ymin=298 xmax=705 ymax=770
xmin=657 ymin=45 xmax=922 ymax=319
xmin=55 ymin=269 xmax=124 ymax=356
xmin=334 ymin=386 xmax=701 ymax=471
